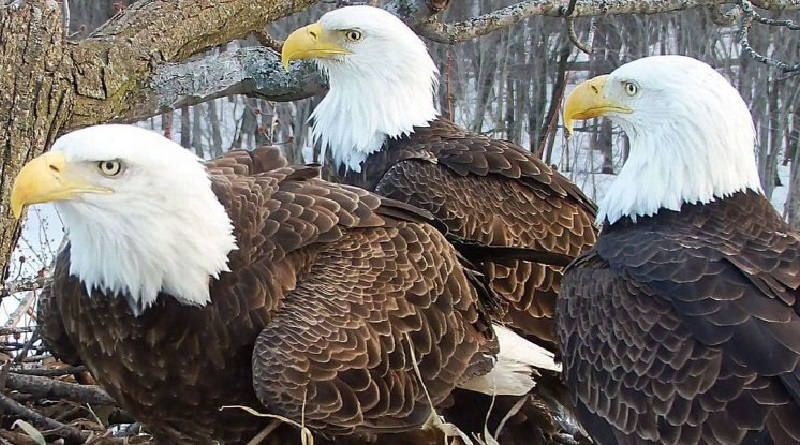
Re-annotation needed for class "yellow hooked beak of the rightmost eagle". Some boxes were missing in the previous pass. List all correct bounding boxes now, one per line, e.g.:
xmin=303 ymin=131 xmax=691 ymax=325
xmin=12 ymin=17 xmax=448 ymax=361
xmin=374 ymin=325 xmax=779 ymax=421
xmin=564 ymin=74 xmax=633 ymax=137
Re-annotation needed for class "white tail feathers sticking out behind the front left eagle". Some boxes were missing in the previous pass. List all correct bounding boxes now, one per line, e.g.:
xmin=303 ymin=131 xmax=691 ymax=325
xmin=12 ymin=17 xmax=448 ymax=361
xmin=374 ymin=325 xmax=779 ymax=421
xmin=458 ymin=324 xmax=561 ymax=396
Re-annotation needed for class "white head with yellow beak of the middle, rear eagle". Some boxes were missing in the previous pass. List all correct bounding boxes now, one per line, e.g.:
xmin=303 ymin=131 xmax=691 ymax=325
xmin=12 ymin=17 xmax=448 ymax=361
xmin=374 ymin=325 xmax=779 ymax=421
xmin=282 ymin=5 xmax=438 ymax=171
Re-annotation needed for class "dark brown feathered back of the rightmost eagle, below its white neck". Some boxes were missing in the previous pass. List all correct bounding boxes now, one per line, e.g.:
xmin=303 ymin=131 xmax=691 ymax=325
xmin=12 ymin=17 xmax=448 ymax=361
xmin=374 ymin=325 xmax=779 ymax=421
xmin=559 ymin=192 xmax=800 ymax=445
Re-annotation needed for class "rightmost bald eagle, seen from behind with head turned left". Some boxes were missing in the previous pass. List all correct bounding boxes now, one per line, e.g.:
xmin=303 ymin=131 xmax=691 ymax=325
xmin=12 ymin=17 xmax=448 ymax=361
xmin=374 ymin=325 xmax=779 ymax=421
xmin=558 ymin=56 xmax=800 ymax=445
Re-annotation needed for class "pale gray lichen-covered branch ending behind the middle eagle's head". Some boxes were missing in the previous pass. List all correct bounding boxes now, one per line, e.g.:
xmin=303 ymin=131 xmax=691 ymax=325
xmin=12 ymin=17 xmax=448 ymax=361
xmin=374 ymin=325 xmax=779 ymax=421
xmin=141 ymin=47 xmax=327 ymax=116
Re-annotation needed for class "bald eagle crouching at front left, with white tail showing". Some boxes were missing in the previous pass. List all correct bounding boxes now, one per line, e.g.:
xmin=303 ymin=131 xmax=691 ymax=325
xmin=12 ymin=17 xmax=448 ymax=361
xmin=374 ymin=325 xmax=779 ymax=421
xmin=11 ymin=125 xmax=556 ymax=444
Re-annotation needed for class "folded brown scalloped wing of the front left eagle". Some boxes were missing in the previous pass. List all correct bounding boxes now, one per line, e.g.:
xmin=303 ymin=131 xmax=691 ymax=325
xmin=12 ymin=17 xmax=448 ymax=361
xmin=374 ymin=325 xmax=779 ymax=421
xmin=253 ymin=155 xmax=492 ymax=434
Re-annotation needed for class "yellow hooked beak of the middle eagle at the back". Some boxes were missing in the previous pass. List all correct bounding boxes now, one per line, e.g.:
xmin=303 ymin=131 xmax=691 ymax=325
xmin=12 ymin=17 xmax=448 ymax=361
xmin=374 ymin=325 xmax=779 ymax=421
xmin=281 ymin=22 xmax=350 ymax=71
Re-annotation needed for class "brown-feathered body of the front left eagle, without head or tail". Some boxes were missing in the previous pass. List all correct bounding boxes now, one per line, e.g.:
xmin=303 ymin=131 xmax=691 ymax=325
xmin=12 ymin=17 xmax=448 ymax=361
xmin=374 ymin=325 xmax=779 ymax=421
xmin=43 ymin=148 xmax=497 ymax=444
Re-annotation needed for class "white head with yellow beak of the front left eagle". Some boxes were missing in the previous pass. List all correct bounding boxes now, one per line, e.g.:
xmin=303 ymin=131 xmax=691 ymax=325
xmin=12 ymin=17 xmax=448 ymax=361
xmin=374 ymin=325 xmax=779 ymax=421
xmin=11 ymin=124 xmax=236 ymax=315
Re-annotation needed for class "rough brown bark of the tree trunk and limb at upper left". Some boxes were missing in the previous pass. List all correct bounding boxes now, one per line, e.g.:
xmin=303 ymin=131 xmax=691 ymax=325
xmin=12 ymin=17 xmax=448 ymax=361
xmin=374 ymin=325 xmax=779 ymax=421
xmin=0 ymin=0 xmax=316 ymax=277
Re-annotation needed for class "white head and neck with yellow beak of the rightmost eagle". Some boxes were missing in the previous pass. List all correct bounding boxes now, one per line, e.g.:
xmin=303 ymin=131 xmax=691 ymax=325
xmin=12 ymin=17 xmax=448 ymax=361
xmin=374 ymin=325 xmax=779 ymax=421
xmin=564 ymin=56 xmax=761 ymax=223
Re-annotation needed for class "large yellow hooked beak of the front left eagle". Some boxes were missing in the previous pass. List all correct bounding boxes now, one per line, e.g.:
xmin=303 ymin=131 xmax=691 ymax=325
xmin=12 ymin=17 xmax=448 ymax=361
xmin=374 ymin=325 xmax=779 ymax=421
xmin=11 ymin=151 xmax=112 ymax=219
